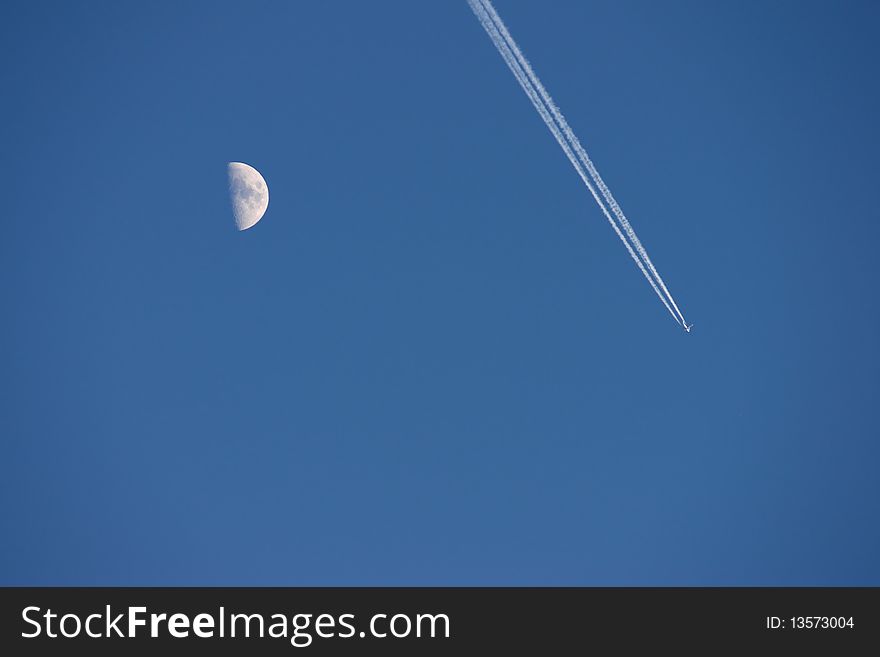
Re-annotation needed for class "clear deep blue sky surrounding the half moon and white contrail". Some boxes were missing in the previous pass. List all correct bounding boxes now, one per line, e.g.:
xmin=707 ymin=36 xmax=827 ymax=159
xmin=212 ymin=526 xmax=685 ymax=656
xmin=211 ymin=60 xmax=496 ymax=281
xmin=0 ymin=0 xmax=880 ymax=585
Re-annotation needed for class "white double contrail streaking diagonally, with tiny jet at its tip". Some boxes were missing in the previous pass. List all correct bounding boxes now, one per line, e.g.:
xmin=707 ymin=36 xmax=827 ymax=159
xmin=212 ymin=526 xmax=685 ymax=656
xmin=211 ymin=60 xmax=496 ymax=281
xmin=468 ymin=0 xmax=687 ymax=327
